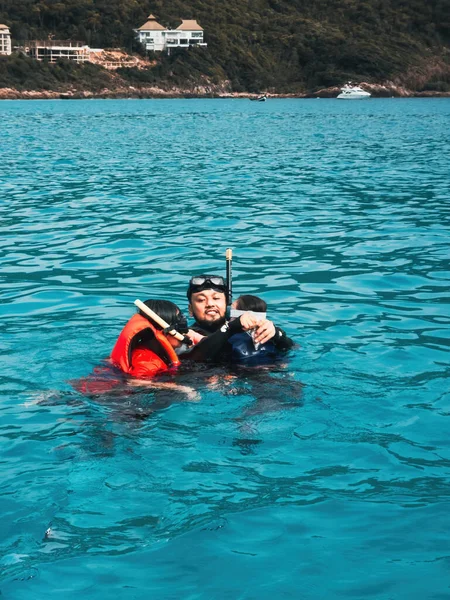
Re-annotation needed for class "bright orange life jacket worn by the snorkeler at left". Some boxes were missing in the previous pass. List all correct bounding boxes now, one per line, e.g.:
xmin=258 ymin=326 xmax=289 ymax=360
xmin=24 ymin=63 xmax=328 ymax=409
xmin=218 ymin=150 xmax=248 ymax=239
xmin=111 ymin=314 xmax=180 ymax=377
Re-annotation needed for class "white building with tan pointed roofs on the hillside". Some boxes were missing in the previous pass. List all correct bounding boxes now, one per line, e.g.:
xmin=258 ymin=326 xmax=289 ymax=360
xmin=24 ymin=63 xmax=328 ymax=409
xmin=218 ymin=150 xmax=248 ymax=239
xmin=135 ymin=15 xmax=207 ymax=52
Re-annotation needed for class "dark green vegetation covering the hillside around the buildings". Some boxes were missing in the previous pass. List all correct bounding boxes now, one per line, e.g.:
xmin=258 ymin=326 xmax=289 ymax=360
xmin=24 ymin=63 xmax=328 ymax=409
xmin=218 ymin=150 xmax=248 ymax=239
xmin=0 ymin=0 xmax=450 ymax=92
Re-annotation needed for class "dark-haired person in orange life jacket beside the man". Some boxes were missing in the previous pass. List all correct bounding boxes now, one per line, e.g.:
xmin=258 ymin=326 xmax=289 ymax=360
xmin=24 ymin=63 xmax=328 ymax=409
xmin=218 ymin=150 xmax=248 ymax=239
xmin=111 ymin=300 xmax=192 ymax=378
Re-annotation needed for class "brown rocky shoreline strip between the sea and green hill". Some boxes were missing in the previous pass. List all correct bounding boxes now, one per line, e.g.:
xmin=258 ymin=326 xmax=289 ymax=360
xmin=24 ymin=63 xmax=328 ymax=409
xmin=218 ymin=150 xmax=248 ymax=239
xmin=0 ymin=82 xmax=450 ymax=100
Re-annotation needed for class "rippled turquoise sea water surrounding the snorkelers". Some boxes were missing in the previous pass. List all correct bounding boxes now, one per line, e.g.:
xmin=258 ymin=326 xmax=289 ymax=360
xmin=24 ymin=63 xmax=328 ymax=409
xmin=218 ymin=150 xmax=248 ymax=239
xmin=0 ymin=99 xmax=450 ymax=600
